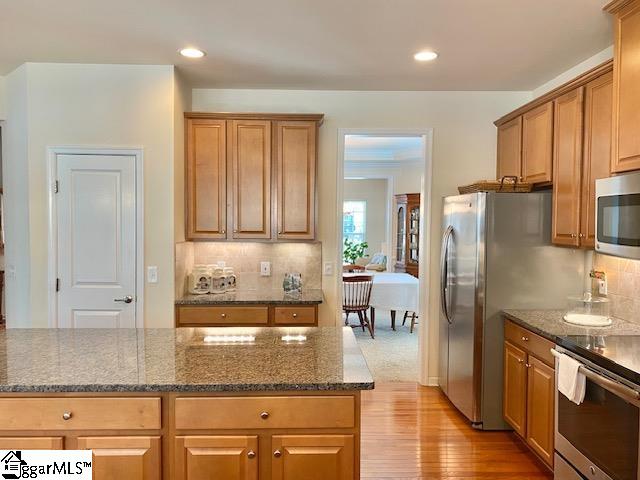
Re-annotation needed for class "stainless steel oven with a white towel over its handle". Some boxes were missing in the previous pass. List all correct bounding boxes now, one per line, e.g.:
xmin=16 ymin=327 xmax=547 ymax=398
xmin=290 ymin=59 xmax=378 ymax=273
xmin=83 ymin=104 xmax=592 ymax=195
xmin=554 ymin=347 xmax=640 ymax=480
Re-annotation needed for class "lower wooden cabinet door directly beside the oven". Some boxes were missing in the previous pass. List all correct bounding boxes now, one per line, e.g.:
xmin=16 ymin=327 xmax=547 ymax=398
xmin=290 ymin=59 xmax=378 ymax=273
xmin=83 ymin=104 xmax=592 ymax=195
xmin=526 ymin=355 xmax=555 ymax=466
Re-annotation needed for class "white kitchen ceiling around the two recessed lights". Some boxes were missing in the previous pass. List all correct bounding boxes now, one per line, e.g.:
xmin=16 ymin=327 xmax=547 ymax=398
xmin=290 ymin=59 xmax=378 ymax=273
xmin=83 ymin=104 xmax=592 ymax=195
xmin=0 ymin=0 xmax=612 ymax=90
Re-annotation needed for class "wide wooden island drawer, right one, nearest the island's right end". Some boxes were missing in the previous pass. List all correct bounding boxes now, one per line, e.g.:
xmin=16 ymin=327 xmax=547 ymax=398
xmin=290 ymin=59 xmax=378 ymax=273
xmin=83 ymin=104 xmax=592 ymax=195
xmin=175 ymin=396 xmax=355 ymax=430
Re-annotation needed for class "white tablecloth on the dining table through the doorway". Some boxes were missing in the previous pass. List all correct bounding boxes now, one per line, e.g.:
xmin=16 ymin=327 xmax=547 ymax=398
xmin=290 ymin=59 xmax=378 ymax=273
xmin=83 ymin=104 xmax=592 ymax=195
xmin=345 ymin=271 xmax=419 ymax=313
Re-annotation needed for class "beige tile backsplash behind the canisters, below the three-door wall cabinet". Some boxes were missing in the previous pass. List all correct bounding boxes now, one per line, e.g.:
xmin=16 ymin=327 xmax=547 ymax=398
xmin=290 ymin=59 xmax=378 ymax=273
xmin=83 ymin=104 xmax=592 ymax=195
xmin=176 ymin=242 xmax=322 ymax=296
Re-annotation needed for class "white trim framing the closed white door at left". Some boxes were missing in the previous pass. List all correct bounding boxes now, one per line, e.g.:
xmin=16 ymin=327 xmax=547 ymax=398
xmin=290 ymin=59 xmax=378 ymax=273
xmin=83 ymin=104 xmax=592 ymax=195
xmin=47 ymin=146 xmax=144 ymax=328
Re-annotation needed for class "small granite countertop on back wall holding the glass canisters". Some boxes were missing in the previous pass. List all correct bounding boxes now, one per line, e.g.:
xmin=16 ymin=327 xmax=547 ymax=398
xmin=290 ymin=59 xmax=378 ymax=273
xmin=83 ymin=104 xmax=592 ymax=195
xmin=176 ymin=289 xmax=323 ymax=305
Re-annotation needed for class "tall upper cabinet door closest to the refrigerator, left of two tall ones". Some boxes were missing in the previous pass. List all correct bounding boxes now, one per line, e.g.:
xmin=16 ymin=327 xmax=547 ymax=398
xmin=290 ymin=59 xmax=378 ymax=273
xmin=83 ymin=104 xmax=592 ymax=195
xmin=552 ymin=88 xmax=583 ymax=247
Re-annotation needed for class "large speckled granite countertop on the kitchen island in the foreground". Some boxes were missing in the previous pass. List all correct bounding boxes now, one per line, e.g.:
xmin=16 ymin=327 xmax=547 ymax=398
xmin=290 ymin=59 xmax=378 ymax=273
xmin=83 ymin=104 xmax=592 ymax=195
xmin=0 ymin=327 xmax=374 ymax=392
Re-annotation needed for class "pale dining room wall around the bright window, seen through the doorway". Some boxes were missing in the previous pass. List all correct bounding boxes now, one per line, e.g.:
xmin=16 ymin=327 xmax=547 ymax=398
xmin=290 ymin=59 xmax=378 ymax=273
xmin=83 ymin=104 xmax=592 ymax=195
xmin=344 ymin=179 xmax=389 ymax=255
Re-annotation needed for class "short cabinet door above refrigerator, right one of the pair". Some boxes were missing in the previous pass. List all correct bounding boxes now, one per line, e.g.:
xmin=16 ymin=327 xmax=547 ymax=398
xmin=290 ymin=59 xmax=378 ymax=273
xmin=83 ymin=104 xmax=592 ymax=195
xmin=522 ymin=102 xmax=553 ymax=183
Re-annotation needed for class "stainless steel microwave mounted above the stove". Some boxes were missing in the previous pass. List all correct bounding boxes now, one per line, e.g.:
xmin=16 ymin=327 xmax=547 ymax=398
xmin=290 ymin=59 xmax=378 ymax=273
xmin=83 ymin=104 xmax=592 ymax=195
xmin=596 ymin=173 xmax=640 ymax=258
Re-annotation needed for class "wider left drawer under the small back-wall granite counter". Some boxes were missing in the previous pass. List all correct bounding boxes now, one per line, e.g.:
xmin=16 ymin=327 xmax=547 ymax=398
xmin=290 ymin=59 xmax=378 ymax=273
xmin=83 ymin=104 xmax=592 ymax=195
xmin=177 ymin=305 xmax=269 ymax=326
